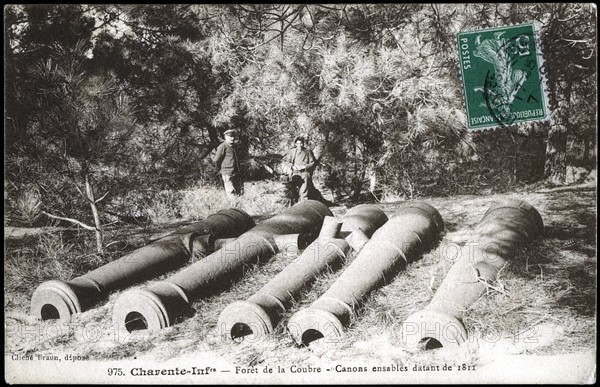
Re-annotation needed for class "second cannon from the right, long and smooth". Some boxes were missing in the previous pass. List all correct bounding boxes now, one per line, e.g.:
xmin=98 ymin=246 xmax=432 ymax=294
xmin=287 ymin=202 xmax=444 ymax=345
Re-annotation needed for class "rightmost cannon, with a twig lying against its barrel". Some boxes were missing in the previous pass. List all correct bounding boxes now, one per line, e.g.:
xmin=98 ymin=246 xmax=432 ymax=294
xmin=402 ymin=200 xmax=544 ymax=350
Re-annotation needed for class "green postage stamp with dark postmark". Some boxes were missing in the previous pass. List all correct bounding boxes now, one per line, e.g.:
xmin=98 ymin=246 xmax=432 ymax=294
xmin=457 ymin=23 xmax=550 ymax=130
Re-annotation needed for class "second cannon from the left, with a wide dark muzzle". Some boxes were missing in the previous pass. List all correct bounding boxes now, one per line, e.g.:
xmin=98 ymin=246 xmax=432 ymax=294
xmin=112 ymin=200 xmax=332 ymax=332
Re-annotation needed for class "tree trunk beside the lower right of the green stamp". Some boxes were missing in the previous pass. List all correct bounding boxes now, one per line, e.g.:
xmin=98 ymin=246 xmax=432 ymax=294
xmin=544 ymin=85 xmax=571 ymax=185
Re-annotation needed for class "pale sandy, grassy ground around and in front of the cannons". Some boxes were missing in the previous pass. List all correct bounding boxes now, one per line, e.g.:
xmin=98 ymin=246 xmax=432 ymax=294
xmin=5 ymin=184 xmax=597 ymax=384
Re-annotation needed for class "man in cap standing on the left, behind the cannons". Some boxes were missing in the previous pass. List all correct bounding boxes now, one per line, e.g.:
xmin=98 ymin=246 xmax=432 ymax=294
xmin=211 ymin=129 xmax=244 ymax=199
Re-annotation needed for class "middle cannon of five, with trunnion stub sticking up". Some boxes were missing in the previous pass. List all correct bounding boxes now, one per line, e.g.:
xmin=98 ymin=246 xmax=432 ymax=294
xmin=217 ymin=205 xmax=387 ymax=339
